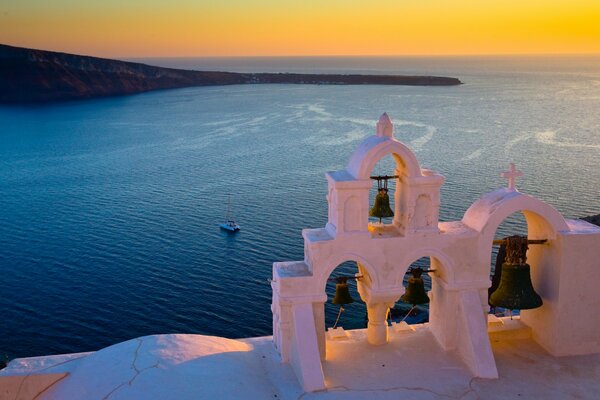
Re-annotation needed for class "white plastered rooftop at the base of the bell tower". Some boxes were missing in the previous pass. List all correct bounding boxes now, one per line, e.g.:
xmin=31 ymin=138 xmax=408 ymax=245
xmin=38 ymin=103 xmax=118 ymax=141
xmin=0 ymin=319 xmax=600 ymax=400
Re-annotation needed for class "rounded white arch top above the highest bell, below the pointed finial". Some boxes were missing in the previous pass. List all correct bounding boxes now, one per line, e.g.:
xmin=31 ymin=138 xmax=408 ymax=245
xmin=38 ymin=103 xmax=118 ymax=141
xmin=346 ymin=136 xmax=421 ymax=179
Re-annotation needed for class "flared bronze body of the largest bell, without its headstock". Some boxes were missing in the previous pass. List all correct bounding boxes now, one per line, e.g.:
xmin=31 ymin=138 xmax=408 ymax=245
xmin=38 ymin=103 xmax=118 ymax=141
xmin=490 ymin=263 xmax=543 ymax=310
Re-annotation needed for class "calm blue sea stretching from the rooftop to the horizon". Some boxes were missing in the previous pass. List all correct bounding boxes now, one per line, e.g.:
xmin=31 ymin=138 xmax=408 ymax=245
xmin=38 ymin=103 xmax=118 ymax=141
xmin=0 ymin=55 xmax=600 ymax=359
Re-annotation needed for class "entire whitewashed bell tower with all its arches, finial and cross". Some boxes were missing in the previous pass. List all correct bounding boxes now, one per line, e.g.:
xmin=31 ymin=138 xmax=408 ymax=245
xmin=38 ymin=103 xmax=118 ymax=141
xmin=271 ymin=114 xmax=600 ymax=391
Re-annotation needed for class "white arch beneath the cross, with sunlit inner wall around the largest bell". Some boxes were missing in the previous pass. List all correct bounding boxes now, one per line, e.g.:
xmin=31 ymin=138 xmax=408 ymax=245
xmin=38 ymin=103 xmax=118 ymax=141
xmin=460 ymin=189 xmax=570 ymax=354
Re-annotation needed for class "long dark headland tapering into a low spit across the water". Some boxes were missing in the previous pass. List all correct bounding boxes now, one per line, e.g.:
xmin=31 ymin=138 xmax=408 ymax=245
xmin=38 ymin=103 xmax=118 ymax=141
xmin=0 ymin=44 xmax=462 ymax=104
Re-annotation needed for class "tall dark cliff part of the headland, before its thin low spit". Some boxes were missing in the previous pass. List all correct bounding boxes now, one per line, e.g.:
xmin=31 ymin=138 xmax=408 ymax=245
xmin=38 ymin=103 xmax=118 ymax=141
xmin=0 ymin=45 xmax=246 ymax=103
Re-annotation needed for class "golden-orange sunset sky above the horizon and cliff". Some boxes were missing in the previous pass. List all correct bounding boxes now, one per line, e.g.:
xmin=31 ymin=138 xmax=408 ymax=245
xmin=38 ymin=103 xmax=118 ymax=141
xmin=0 ymin=0 xmax=600 ymax=57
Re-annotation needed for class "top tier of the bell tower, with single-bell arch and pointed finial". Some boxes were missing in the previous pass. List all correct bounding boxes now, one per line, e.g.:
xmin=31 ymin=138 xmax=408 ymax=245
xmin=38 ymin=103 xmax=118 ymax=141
xmin=326 ymin=113 xmax=444 ymax=237
